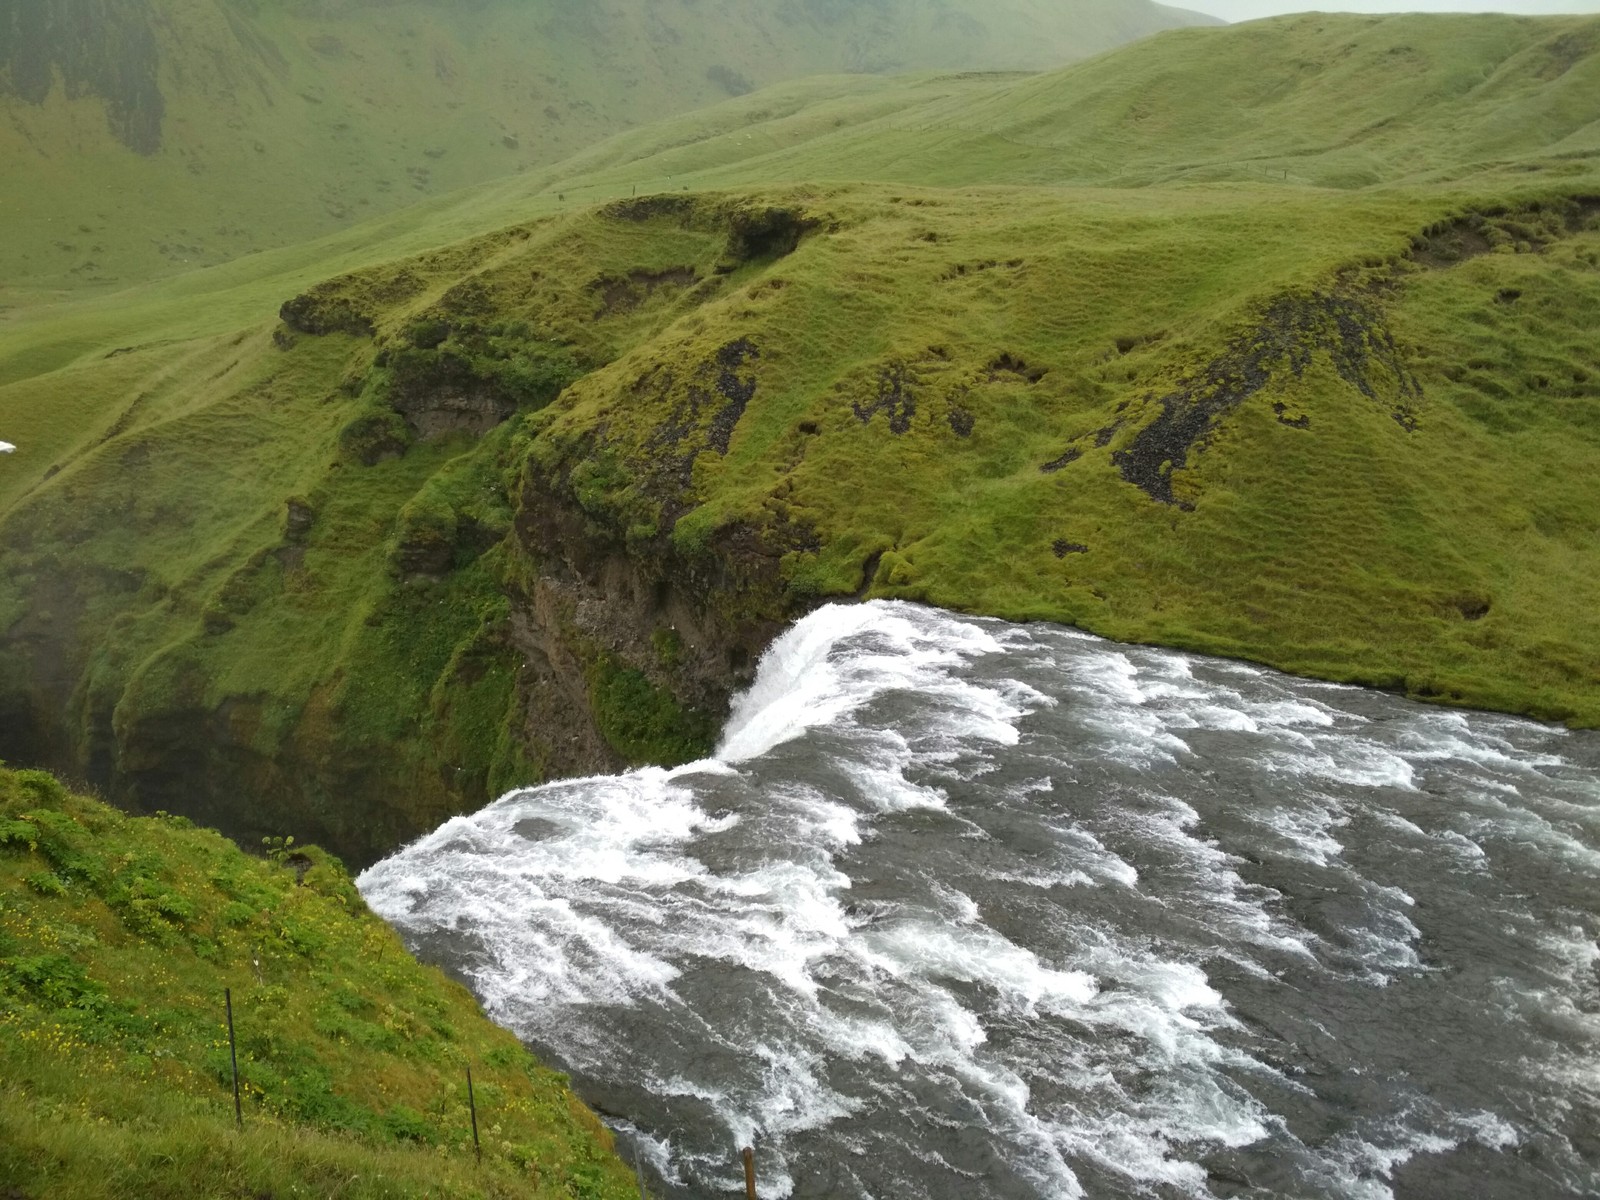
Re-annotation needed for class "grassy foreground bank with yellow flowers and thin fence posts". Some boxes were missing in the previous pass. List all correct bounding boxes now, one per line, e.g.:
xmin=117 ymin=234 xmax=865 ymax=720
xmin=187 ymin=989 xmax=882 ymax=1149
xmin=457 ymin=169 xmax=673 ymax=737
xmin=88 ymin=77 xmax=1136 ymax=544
xmin=0 ymin=770 xmax=637 ymax=1200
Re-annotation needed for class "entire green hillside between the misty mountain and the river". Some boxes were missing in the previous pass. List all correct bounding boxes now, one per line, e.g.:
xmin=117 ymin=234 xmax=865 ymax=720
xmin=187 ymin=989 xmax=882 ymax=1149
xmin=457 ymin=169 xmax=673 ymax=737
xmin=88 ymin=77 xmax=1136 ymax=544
xmin=0 ymin=16 xmax=1600 ymax=861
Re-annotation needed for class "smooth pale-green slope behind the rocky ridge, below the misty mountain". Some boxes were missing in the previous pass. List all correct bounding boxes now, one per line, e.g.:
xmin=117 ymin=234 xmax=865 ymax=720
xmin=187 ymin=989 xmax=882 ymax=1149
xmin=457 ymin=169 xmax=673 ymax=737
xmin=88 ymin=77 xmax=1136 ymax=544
xmin=9 ymin=16 xmax=1600 ymax=390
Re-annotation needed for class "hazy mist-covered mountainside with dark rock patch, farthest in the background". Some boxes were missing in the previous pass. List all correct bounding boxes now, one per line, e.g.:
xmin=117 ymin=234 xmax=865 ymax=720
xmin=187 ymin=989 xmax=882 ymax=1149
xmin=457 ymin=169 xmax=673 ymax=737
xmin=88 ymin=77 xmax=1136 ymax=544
xmin=0 ymin=0 xmax=1202 ymax=299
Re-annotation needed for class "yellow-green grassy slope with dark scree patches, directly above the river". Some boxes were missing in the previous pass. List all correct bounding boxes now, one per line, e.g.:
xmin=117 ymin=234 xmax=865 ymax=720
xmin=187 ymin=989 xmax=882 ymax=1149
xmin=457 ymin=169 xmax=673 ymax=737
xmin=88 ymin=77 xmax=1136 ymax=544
xmin=542 ymin=182 xmax=1600 ymax=723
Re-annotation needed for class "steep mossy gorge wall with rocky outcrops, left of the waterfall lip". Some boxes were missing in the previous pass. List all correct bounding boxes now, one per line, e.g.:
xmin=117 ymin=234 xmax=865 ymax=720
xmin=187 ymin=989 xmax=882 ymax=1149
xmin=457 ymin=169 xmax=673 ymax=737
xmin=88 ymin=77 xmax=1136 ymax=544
xmin=0 ymin=200 xmax=802 ymax=862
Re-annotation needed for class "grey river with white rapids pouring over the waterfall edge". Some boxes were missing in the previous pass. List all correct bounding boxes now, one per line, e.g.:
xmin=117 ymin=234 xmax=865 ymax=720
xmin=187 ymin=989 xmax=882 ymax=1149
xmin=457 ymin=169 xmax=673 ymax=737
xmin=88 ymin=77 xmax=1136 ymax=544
xmin=360 ymin=603 xmax=1600 ymax=1200
